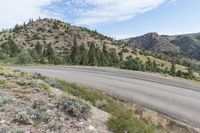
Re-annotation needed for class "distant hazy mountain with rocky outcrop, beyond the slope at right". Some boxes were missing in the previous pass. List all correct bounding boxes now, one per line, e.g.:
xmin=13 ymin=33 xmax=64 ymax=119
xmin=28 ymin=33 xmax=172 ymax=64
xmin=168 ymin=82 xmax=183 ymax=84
xmin=124 ymin=33 xmax=200 ymax=61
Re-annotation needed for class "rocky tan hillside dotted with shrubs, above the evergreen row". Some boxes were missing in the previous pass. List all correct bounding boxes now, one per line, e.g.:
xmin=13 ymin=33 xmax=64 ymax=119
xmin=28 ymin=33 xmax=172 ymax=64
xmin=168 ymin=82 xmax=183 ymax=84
xmin=0 ymin=19 xmax=119 ymax=54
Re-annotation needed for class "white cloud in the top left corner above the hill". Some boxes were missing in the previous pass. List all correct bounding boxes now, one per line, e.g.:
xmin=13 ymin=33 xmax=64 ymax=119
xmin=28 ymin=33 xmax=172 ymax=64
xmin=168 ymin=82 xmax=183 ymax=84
xmin=0 ymin=0 xmax=53 ymax=29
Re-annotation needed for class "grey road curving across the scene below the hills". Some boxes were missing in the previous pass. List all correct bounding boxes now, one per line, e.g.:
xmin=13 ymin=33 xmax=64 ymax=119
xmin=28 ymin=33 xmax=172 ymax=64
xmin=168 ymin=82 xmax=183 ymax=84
xmin=8 ymin=67 xmax=200 ymax=128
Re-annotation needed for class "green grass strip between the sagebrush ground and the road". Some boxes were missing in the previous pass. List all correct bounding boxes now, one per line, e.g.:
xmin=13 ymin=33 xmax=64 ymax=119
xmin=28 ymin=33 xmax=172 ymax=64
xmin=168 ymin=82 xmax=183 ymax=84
xmin=57 ymin=80 xmax=156 ymax=133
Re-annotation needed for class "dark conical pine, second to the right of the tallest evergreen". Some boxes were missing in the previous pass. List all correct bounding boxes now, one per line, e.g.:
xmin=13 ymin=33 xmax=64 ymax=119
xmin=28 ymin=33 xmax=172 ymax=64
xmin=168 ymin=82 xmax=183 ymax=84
xmin=88 ymin=42 xmax=98 ymax=66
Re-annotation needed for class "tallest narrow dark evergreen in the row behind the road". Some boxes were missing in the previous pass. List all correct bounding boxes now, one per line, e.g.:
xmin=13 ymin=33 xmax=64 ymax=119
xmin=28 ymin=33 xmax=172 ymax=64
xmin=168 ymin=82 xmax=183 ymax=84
xmin=71 ymin=38 xmax=79 ymax=65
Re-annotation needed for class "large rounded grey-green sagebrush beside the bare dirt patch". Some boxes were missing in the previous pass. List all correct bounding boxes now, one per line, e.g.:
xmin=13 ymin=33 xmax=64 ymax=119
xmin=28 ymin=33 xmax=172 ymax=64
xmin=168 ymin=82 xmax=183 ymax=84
xmin=59 ymin=98 xmax=91 ymax=119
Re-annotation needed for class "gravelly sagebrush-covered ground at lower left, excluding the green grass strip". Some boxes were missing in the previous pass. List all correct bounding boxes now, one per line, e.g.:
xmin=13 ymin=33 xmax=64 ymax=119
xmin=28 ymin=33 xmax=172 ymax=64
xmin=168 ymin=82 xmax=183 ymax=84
xmin=0 ymin=68 xmax=108 ymax=133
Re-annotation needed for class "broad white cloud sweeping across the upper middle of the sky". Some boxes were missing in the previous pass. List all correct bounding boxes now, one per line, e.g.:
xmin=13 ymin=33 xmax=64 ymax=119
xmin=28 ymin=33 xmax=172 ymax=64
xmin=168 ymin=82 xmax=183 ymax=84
xmin=72 ymin=0 xmax=166 ymax=25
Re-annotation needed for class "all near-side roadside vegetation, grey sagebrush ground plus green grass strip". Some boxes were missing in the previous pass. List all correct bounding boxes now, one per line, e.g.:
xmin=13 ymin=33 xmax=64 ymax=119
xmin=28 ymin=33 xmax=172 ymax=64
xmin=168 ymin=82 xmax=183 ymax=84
xmin=0 ymin=68 xmax=157 ymax=133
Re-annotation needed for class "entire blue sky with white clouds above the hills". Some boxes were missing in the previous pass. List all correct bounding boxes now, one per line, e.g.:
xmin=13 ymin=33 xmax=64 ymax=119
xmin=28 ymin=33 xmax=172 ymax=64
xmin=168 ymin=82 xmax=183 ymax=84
xmin=0 ymin=0 xmax=200 ymax=39
